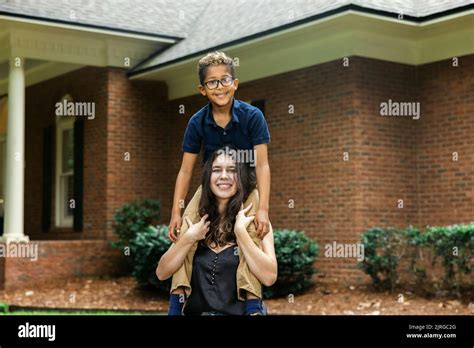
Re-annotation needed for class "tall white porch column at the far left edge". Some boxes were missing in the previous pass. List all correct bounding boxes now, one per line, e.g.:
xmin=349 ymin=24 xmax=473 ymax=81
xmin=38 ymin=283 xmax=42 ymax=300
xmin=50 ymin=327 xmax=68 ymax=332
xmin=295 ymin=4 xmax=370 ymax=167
xmin=0 ymin=57 xmax=29 ymax=243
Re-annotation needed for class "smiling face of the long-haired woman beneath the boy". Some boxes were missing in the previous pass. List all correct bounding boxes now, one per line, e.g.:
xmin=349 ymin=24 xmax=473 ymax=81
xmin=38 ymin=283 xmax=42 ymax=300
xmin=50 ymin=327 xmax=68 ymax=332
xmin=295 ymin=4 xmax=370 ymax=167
xmin=210 ymin=154 xmax=237 ymax=200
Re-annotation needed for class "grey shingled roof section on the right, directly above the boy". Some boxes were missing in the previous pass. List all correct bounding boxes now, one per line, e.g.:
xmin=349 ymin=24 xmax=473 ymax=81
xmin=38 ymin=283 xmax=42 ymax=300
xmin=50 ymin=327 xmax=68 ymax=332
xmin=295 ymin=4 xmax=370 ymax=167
xmin=130 ymin=0 xmax=474 ymax=75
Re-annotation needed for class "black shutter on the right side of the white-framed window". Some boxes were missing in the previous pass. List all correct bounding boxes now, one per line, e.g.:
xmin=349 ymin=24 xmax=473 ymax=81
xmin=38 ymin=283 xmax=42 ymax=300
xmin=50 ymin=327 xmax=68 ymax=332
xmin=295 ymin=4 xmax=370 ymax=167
xmin=73 ymin=120 xmax=84 ymax=231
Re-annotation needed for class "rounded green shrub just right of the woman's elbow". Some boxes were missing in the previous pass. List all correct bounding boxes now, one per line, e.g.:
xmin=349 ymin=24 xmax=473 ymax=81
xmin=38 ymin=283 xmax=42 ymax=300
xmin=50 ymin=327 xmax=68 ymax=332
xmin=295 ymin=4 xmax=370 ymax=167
xmin=264 ymin=229 xmax=319 ymax=298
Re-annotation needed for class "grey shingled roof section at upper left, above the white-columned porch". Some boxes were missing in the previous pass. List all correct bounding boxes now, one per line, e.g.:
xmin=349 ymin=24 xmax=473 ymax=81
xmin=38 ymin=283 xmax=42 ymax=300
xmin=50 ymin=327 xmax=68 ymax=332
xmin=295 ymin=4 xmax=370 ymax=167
xmin=0 ymin=0 xmax=209 ymax=38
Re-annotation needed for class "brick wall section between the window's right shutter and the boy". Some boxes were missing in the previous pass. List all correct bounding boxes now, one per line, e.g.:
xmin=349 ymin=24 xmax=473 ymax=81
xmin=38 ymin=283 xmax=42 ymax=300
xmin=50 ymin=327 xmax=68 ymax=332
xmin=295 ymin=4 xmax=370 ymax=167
xmin=106 ymin=69 xmax=171 ymax=238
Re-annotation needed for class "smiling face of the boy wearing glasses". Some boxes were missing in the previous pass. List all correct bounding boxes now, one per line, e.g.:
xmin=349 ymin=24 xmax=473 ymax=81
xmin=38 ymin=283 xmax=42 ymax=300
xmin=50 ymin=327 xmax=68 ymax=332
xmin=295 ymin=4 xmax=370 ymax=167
xmin=198 ymin=64 xmax=239 ymax=107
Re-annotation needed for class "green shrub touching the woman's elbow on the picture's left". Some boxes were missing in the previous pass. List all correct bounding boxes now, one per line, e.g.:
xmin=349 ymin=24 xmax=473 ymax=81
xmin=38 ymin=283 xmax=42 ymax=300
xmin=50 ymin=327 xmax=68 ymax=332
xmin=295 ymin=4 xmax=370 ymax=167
xmin=130 ymin=225 xmax=171 ymax=294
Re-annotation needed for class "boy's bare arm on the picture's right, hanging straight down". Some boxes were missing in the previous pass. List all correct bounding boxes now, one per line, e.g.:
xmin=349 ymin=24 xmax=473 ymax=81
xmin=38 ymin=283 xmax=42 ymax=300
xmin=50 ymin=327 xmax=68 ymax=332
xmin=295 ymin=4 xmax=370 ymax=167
xmin=254 ymin=144 xmax=270 ymax=238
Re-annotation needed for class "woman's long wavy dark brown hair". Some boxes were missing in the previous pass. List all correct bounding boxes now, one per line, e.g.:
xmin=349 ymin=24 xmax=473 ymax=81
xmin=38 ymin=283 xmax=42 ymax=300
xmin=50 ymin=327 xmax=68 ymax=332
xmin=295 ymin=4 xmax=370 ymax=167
xmin=199 ymin=146 xmax=257 ymax=247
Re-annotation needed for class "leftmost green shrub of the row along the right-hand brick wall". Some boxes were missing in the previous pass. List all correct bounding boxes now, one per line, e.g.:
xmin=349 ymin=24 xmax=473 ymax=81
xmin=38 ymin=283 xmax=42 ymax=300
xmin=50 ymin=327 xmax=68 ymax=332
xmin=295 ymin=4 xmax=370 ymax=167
xmin=359 ymin=226 xmax=419 ymax=291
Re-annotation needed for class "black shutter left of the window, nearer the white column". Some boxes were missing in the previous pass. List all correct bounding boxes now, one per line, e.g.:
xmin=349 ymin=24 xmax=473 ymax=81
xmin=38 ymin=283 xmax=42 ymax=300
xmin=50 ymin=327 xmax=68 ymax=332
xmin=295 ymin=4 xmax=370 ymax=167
xmin=41 ymin=126 xmax=53 ymax=232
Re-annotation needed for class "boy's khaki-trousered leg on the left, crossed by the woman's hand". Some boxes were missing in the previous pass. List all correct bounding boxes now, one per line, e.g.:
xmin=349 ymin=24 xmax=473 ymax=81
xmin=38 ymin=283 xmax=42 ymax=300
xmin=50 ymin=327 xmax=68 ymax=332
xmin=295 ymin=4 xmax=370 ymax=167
xmin=170 ymin=186 xmax=202 ymax=296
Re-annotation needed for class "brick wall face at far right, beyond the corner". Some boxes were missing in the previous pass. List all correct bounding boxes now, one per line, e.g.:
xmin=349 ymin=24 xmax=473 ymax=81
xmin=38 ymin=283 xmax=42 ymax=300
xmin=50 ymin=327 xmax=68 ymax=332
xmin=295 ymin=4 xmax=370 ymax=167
xmin=417 ymin=55 xmax=474 ymax=226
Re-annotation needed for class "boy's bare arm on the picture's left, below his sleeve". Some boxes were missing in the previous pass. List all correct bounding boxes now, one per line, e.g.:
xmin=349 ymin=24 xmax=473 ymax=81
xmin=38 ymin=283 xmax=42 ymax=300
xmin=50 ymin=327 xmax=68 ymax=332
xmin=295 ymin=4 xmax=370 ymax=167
xmin=168 ymin=152 xmax=198 ymax=242
